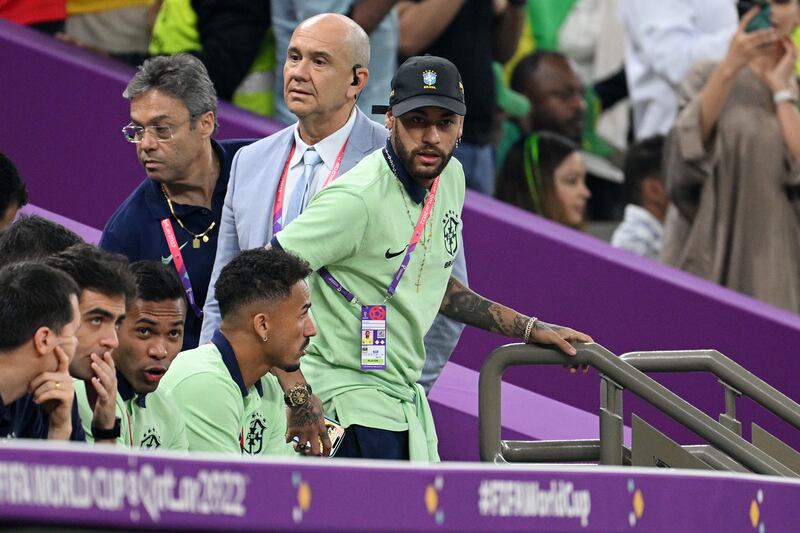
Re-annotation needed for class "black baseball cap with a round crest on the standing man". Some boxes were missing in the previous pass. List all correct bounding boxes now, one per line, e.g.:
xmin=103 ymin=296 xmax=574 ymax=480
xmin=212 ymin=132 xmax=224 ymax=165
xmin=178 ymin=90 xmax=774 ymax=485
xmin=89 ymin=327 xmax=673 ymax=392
xmin=372 ymin=55 xmax=467 ymax=116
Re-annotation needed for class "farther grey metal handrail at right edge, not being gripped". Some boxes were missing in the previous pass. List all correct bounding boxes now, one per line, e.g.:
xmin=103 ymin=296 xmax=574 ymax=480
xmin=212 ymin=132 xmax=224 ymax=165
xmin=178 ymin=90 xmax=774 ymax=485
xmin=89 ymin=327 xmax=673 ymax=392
xmin=620 ymin=350 xmax=800 ymax=435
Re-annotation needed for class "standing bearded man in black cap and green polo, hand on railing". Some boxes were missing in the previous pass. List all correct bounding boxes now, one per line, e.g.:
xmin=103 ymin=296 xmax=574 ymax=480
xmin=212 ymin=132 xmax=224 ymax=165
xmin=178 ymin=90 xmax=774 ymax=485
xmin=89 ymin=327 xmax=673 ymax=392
xmin=272 ymin=56 xmax=591 ymax=461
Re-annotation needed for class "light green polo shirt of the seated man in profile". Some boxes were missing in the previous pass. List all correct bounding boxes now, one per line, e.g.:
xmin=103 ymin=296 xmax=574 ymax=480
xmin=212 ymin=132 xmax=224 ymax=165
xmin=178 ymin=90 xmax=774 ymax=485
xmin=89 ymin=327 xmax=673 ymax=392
xmin=159 ymin=343 xmax=296 ymax=455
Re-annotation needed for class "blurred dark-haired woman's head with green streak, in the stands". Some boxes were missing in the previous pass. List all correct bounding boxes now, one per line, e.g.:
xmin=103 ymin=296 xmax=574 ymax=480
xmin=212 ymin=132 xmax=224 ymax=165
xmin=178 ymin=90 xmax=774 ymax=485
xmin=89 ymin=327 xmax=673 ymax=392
xmin=497 ymin=132 xmax=591 ymax=229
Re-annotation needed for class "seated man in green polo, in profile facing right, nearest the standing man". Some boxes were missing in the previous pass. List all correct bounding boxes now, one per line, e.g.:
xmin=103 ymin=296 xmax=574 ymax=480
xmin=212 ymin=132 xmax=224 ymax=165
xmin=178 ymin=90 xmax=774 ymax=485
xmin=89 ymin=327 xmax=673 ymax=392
xmin=160 ymin=249 xmax=316 ymax=455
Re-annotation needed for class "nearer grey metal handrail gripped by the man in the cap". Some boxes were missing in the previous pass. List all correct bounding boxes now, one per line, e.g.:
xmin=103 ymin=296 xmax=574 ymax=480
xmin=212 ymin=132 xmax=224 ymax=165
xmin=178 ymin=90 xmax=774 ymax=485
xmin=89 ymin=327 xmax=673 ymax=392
xmin=478 ymin=344 xmax=796 ymax=477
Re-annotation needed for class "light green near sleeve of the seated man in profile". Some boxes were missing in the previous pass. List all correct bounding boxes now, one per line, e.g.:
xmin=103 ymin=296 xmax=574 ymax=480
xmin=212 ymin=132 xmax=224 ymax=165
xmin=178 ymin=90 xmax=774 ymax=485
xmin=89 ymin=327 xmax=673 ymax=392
xmin=171 ymin=372 xmax=244 ymax=455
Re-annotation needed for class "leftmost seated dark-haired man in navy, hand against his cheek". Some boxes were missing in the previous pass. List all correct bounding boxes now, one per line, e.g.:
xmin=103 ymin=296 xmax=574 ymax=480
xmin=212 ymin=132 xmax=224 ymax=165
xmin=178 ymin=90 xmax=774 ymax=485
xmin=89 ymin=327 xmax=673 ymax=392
xmin=0 ymin=263 xmax=83 ymax=440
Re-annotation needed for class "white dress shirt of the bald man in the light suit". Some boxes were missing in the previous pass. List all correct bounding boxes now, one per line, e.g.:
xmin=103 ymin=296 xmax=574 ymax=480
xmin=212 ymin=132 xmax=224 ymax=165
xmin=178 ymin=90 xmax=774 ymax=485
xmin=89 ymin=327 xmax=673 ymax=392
xmin=283 ymin=108 xmax=356 ymax=209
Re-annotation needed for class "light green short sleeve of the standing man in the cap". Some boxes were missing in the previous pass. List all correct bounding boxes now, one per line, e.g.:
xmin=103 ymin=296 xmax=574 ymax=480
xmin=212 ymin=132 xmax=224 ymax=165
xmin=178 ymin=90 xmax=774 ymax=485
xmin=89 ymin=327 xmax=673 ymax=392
xmin=273 ymin=183 xmax=369 ymax=270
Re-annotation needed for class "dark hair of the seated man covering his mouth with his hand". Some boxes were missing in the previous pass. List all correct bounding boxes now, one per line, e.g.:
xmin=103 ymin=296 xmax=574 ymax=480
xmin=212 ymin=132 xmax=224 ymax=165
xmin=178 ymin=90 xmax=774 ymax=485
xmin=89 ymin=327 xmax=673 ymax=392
xmin=44 ymin=244 xmax=136 ymax=301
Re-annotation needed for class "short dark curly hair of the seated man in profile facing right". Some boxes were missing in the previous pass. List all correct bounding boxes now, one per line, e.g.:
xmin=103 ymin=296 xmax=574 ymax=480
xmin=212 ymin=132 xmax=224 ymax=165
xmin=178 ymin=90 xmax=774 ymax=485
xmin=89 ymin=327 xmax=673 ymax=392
xmin=214 ymin=248 xmax=311 ymax=319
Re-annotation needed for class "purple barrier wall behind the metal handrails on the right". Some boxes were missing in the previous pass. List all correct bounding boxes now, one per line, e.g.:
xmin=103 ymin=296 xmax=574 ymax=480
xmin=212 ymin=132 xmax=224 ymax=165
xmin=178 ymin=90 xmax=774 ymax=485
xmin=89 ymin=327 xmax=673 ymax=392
xmin=454 ymin=192 xmax=800 ymax=448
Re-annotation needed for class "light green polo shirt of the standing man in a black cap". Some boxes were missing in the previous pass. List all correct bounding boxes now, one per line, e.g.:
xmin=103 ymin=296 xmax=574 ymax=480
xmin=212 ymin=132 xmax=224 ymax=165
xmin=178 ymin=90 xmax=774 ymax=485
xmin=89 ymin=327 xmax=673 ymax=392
xmin=277 ymin=150 xmax=464 ymax=461
